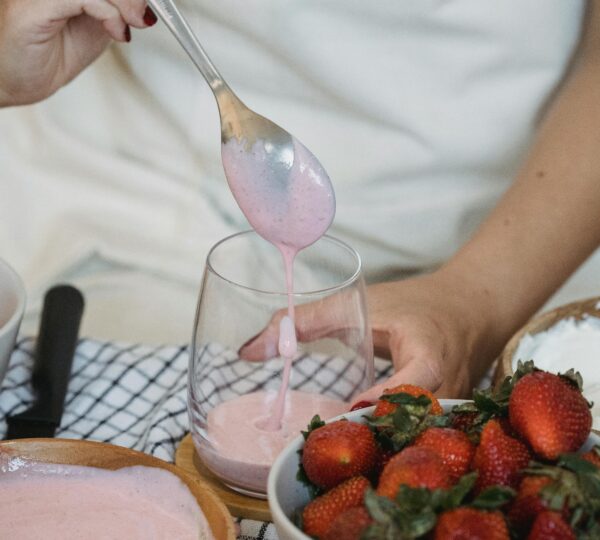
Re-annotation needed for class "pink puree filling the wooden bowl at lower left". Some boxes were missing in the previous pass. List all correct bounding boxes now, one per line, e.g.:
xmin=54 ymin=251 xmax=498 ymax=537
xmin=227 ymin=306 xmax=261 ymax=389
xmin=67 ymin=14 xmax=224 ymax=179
xmin=0 ymin=456 xmax=214 ymax=540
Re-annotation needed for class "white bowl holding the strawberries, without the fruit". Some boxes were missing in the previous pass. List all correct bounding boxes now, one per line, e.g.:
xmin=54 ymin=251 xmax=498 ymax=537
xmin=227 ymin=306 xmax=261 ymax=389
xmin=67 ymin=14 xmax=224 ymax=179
xmin=267 ymin=399 xmax=600 ymax=540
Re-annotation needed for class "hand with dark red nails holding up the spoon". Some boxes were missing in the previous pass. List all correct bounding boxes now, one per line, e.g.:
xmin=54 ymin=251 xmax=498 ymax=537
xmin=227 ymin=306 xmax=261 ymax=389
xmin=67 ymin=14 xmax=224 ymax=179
xmin=0 ymin=0 xmax=156 ymax=106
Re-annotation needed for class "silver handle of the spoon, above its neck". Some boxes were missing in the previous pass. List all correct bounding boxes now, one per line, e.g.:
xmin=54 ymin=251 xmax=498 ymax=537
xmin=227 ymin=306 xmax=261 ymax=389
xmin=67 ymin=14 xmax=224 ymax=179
xmin=148 ymin=0 xmax=227 ymax=95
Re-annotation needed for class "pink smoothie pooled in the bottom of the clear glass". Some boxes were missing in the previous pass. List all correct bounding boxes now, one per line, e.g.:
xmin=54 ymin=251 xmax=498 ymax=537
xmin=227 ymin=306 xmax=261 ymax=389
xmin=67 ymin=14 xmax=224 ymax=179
xmin=197 ymin=390 xmax=348 ymax=494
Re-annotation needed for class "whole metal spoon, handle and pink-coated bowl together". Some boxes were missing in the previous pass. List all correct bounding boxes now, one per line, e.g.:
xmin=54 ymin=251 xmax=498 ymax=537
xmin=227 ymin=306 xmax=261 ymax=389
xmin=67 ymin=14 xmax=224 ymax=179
xmin=148 ymin=0 xmax=335 ymax=243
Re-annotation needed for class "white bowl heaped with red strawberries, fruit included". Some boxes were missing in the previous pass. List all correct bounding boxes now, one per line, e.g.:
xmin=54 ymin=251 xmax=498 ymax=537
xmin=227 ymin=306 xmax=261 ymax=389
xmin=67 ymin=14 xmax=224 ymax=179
xmin=268 ymin=362 xmax=600 ymax=540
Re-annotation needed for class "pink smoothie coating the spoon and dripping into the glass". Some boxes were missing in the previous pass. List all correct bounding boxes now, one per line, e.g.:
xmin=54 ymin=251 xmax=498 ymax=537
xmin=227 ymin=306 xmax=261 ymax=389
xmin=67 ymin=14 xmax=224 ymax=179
xmin=221 ymin=139 xmax=335 ymax=431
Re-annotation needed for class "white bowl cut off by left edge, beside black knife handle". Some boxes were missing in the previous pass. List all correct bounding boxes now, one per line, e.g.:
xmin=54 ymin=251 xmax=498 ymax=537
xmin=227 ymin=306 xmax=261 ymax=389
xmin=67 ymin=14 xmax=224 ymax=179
xmin=0 ymin=259 xmax=25 ymax=383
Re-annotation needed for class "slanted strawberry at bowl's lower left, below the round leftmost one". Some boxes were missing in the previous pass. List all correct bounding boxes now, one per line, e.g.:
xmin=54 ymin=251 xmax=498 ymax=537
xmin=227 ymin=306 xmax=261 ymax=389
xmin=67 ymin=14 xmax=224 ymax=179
xmin=302 ymin=476 xmax=370 ymax=538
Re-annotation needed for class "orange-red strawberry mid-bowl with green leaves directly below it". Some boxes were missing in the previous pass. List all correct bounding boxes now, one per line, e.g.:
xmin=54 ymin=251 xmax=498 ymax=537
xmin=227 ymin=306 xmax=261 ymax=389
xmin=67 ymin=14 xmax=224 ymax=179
xmin=377 ymin=446 xmax=451 ymax=499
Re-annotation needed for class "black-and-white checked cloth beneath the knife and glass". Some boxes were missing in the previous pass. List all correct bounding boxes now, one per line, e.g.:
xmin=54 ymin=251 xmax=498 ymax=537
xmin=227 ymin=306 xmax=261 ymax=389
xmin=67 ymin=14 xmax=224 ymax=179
xmin=0 ymin=338 xmax=391 ymax=540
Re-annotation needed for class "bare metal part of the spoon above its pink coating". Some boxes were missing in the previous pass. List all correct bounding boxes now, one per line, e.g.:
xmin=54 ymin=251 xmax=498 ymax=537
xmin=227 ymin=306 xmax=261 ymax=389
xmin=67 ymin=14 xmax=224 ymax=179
xmin=148 ymin=0 xmax=294 ymax=173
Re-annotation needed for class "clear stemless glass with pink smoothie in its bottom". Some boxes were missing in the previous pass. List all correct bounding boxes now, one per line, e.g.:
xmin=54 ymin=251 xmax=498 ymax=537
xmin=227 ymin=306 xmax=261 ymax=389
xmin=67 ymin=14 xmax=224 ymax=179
xmin=188 ymin=231 xmax=373 ymax=498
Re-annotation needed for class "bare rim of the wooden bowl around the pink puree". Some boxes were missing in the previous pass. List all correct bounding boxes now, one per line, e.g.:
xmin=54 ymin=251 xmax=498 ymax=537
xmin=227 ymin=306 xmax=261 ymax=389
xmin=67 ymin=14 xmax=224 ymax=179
xmin=0 ymin=439 xmax=236 ymax=540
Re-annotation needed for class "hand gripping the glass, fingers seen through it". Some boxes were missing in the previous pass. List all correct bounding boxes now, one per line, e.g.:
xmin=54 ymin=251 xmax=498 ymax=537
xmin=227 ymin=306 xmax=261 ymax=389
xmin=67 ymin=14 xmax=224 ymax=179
xmin=240 ymin=271 xmax=501 ymax=401
